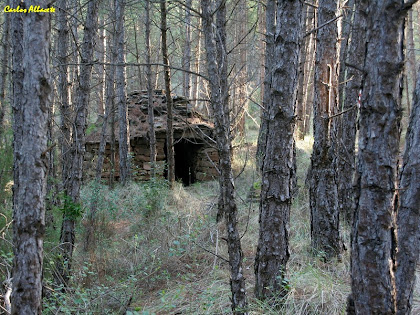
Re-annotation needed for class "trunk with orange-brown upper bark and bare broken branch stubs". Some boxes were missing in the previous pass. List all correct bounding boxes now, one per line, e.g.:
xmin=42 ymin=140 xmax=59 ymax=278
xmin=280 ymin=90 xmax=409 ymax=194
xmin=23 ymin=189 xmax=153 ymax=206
xmin=309 ymin=0 xmax=342 ymax=259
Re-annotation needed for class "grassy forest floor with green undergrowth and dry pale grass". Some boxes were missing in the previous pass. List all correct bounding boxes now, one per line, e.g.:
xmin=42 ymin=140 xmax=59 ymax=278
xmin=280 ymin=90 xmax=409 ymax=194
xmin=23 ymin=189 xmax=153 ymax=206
xmin=2 ymin=130 xmax=420 ymax=315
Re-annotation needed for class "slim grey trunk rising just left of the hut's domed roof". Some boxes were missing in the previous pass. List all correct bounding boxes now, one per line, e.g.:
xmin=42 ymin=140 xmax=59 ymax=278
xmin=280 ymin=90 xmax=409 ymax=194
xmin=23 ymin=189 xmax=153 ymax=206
xmin=114 ymin=0 xmax=130 ymax=185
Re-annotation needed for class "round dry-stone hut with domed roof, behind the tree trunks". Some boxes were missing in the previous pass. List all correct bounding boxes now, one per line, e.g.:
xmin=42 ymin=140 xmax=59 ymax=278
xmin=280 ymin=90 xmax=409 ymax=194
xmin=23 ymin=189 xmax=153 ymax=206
xmin=85 ymin=90 xmax=218 ymax=185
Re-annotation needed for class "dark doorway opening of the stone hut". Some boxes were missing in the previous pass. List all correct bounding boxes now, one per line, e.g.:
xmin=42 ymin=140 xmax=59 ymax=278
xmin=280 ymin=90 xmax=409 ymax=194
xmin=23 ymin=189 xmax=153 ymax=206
xmin=170 ymin=139 xmax=203 ymax=186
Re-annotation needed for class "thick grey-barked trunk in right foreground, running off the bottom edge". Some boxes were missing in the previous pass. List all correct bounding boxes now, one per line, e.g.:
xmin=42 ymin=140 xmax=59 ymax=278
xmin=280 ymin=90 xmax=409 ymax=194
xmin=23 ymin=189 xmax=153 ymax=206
xmin=349 ymin=0 xmax=414 ymax=314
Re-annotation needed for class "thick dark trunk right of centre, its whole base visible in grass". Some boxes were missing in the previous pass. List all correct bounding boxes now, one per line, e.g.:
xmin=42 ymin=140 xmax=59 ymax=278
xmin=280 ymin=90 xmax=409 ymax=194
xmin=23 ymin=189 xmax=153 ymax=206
xmin=254 ymin=1 xmax=303 ymax=299
